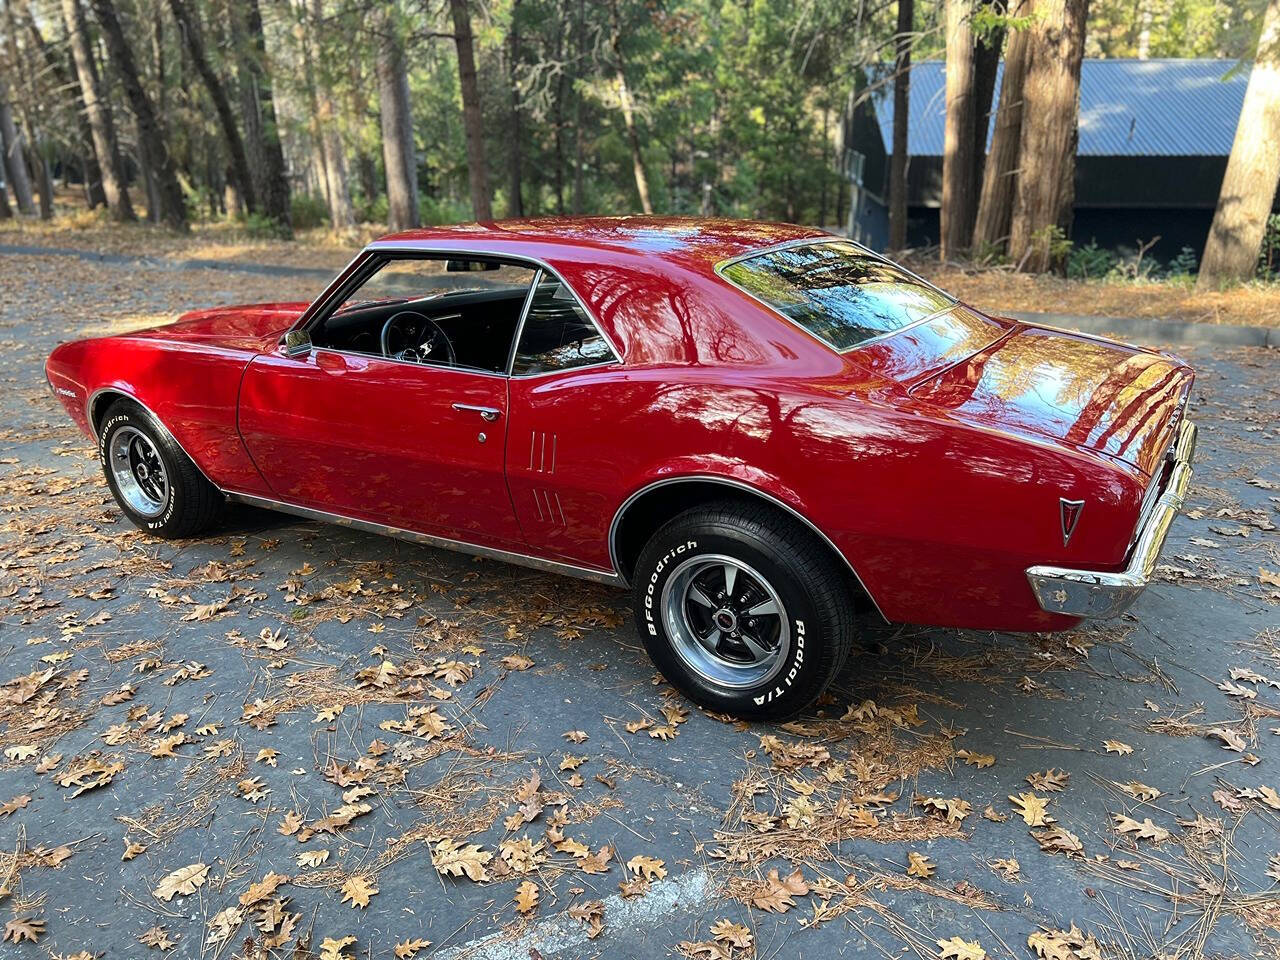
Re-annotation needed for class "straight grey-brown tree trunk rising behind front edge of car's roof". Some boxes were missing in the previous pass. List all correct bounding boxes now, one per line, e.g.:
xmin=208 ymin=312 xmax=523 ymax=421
xmin=378 ymin=10 xmax=419 ymax=230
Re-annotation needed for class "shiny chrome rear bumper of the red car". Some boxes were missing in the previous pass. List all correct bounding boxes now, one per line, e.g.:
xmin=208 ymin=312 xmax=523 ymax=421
xmin=1027 ymin=420 xmax=1197 ymax=617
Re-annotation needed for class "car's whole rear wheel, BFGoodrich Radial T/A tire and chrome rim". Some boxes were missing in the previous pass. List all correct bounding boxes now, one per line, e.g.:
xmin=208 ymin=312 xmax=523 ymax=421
xmin=634 ymin=502 xmax=854 ymax=718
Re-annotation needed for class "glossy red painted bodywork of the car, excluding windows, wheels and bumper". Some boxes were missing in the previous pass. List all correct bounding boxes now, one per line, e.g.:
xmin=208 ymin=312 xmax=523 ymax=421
xmin=47 ymin=218 xmax=1193 ymax=630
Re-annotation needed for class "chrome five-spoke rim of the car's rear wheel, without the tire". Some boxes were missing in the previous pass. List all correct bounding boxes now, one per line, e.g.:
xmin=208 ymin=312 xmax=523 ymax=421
xmin=662 ymin=554 xmax=791 ymax=687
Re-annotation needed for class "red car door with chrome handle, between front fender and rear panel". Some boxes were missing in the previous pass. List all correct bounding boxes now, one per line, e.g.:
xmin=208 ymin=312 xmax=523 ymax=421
xmin=238 ymin=253 xmax=534 ymax=548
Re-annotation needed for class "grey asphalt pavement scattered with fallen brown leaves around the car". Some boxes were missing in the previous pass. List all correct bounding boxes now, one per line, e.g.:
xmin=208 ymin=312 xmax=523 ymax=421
xmin=0 ymin=256 xmax=1280 ymax=960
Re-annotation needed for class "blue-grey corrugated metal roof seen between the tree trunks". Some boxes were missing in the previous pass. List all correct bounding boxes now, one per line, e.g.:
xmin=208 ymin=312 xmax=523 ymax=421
xmin=876 ymin=60 xmax=1249 ymax=156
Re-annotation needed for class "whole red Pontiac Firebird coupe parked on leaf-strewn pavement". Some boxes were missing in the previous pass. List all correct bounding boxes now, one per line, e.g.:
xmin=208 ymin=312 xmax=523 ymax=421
xmin=46 ymin=218 xmax=1196 ymax=717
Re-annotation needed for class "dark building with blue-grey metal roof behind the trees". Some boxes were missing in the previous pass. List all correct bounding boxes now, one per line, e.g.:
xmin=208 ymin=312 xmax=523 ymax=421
xmin=846 ymin=59 xmax=1264 ymax=257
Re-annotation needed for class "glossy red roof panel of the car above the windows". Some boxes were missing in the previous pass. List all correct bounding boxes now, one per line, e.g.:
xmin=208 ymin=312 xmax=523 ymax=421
xmin=376 ymin=216 xmax=831 ymax=270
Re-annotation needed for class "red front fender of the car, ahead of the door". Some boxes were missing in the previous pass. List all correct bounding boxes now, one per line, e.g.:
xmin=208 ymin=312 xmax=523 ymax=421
xmin=45 ymin=333 xmax=268 ymax=494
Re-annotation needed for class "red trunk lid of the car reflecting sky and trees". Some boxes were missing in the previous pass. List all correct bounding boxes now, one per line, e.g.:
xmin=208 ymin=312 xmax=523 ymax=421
xmin=909 ymin=317 xmax=1194 ymax=476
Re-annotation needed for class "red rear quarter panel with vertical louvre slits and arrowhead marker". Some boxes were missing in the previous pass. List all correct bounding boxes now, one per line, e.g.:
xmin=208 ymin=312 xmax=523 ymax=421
xmin=507 ymin=357 xmax=1140 ymax=630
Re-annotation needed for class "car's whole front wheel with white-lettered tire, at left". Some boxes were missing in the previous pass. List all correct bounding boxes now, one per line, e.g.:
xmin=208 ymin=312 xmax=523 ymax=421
xmin=97 ymin=399 xmax=223 ymax=538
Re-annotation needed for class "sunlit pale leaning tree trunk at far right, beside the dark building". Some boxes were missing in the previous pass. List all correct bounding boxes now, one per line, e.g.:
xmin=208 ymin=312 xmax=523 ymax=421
xmin=1196 ymin=0 xmax=1280 ymax=289
